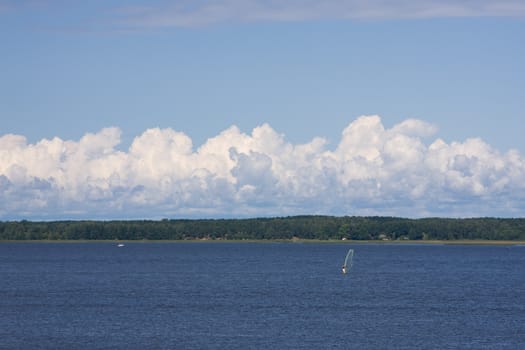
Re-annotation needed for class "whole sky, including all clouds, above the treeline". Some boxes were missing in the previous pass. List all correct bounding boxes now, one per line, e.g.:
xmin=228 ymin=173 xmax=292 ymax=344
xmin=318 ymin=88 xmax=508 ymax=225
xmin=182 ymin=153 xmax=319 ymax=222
xmin=0 ymin=0 xmax=525 ymax=220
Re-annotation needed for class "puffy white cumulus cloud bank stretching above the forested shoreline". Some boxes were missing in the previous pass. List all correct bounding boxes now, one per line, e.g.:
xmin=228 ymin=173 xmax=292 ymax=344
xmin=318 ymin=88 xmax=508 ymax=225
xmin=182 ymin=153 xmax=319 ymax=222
xmin=0 ymin=116 xmax=525 ymax=220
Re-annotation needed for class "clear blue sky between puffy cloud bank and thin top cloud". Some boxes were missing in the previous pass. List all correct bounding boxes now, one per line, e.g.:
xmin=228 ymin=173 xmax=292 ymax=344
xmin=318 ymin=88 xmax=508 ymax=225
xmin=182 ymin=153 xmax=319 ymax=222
xmin=0 ymin=3 xmax=525 ymax=152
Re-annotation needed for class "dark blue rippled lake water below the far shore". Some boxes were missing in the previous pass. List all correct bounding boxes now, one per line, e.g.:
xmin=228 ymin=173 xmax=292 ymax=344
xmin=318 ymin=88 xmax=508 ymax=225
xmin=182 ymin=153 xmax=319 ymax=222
xmin=0 ymin=243 xmax=525 ymax=349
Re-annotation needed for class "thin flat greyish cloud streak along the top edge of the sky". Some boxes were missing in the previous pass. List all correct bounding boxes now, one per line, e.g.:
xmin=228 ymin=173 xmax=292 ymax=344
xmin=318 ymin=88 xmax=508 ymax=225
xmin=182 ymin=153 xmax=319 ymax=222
xmin=112 ymin=0 xmax=525 ymax=28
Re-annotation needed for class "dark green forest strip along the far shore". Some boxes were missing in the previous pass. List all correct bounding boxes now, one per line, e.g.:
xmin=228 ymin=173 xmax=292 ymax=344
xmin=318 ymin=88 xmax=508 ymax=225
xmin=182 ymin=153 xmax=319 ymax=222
xmin=0 ymin=216 xmax=525 ymax=241
